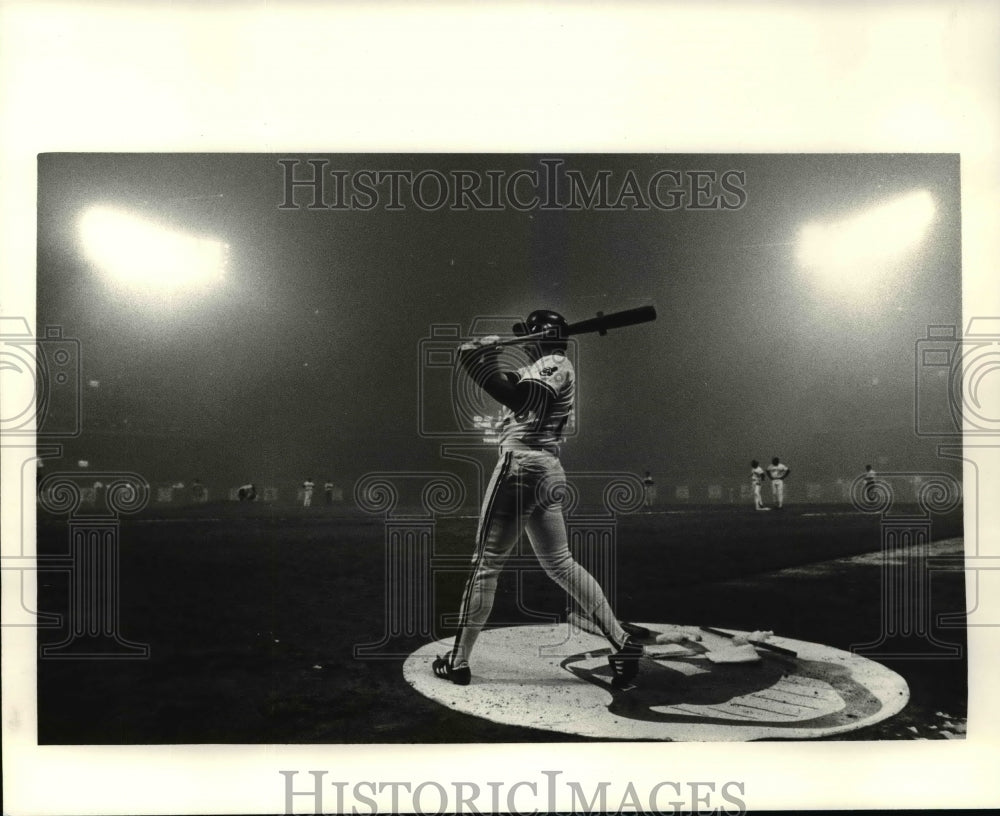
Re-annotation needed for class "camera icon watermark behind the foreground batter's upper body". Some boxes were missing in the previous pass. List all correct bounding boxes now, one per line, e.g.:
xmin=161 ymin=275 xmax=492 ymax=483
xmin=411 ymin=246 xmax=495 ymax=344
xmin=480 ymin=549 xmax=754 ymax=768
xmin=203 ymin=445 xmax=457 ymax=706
xmin=417 ymin=316 xmax=579 ymax=444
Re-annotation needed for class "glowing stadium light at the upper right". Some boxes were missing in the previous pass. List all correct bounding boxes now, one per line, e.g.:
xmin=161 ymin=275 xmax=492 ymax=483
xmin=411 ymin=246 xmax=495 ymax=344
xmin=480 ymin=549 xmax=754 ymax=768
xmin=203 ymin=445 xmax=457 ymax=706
xmin=798 ymin=190 xmax=935 ymax=290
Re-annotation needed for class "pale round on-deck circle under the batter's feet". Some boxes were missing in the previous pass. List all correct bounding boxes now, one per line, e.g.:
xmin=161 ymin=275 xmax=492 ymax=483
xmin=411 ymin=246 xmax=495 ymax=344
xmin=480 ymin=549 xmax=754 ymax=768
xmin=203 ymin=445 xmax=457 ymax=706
xmin=403 ymin=624 xmax=909 ymax=742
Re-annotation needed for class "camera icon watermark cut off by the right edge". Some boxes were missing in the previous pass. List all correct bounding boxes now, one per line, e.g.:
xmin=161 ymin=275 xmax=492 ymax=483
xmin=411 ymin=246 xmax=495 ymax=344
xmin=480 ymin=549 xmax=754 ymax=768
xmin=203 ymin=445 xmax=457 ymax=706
xmin=914 ymin=317 xmax=1000 ymax=438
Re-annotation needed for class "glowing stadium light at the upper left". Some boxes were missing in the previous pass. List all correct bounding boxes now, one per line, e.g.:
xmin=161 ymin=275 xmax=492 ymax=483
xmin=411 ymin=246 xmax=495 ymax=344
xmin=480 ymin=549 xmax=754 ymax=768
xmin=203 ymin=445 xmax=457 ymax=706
xmin=80 ymin=207 xmax=229 ymax=293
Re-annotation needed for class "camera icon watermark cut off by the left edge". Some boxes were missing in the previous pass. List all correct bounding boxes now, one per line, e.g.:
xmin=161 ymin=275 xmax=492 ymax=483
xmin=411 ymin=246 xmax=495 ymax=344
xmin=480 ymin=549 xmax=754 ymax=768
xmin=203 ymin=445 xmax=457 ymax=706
xmin=0 ymin=317 xmax=81 ymax=438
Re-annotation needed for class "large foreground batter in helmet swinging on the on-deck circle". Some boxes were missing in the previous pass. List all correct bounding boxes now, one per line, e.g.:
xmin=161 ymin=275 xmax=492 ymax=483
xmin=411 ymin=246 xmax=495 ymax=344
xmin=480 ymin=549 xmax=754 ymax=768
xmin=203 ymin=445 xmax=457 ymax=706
xmin=432 ymin=310 xmax=643 ymax=688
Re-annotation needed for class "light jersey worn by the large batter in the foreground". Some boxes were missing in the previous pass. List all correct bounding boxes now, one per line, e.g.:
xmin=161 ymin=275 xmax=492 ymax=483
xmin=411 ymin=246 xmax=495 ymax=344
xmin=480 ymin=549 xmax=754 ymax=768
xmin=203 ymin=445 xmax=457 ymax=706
xmin=498 ymin=352 xmax=576 ymax=450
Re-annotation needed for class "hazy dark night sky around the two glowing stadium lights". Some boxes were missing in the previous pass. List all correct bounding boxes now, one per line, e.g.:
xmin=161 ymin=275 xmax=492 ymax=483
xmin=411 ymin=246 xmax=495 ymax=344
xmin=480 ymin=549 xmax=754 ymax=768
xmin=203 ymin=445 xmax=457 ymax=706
xmin=37 ymin=154 xmax=961 ymax=488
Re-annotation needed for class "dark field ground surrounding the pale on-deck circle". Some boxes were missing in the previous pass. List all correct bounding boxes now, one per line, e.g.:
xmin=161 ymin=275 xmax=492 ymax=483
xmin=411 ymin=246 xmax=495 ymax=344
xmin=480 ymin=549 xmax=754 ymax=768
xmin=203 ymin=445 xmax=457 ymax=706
xmin=38 ymin=503 xmax=967 ymax=744
